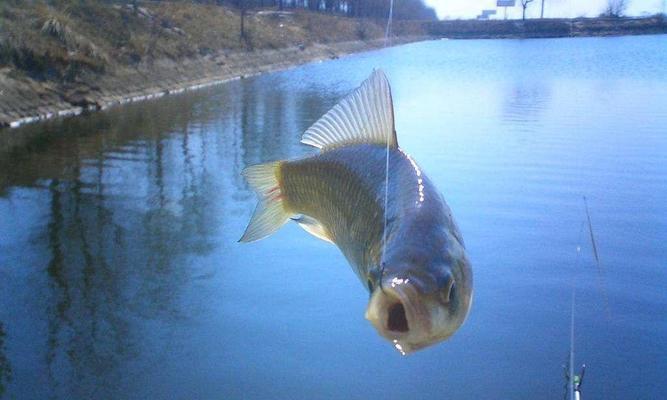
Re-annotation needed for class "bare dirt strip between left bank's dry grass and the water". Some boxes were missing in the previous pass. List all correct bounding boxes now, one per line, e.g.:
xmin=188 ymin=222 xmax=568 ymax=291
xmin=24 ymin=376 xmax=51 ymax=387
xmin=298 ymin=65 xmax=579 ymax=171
xmin=0 ymin=36 xmax=426 ymax=130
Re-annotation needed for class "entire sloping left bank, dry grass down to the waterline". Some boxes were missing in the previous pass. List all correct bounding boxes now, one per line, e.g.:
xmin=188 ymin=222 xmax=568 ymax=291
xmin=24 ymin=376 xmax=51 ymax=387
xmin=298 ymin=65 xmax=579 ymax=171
xmin=0 ymin=1 xmax=425 ymax=126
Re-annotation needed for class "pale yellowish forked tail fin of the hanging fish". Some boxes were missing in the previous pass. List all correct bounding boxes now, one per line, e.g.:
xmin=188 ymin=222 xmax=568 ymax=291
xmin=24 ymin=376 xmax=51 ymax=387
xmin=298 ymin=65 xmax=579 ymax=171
xmin=239 ymin=161 xmax=290 ymax=242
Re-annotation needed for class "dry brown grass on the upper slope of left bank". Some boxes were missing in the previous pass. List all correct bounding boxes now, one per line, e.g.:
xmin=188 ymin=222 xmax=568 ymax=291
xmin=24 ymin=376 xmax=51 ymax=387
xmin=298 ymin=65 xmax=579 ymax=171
xmin=0 ymin=0 xmax=428 ymax=81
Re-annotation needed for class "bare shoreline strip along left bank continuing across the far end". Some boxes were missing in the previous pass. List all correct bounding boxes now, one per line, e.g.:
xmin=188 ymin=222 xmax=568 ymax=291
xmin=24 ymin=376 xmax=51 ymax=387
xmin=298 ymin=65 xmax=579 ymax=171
xmin=0 ymin=17 xmax=667 ymax=134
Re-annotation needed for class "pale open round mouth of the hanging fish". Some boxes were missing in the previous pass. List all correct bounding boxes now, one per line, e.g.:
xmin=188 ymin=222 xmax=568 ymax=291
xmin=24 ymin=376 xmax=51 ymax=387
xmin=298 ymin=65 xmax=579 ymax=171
xmin=366 ymin=279 xmax=431 ymax=355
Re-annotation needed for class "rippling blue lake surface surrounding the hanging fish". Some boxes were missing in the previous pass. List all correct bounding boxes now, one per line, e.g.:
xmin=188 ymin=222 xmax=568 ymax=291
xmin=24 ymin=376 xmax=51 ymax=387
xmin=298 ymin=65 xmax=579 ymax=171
xmin=0 ymin=36 xmax=667 ymax=400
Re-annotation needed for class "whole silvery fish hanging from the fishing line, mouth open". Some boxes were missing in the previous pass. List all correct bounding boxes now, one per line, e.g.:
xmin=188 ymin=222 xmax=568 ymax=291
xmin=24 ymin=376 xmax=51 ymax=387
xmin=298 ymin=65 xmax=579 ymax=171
xmin=239 ymin=69 xmax=473 ymax=355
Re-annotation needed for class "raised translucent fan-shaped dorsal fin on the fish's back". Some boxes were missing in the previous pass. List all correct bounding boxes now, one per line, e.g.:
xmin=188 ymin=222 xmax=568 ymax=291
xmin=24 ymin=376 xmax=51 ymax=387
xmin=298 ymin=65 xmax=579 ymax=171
xmin=301 ymin=69 xmax=398 ymax=150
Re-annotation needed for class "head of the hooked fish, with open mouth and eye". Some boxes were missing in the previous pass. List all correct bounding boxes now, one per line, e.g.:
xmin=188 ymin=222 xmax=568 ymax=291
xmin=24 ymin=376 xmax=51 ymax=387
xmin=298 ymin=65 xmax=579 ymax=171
xmin=366 ymin=242 xmax=472 ymax=355
